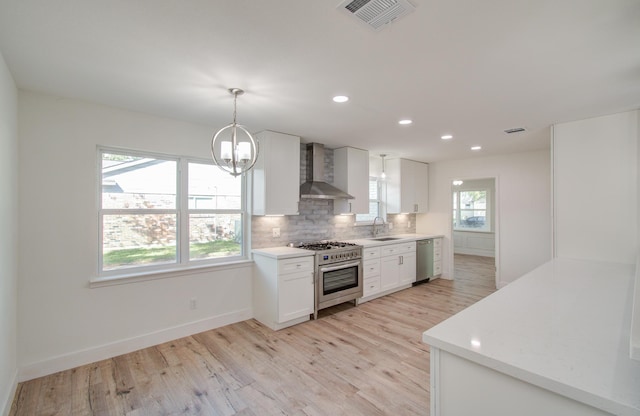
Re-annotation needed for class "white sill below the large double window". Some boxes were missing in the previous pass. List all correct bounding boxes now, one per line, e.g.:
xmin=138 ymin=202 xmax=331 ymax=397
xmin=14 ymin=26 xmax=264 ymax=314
xmin=89 ymin=260 xmax=253 ymax=289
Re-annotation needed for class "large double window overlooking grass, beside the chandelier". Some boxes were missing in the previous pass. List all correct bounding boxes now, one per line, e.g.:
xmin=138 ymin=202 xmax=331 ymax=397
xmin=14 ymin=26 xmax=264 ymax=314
xmin=99 ymin=149 xmax=247 ymax=275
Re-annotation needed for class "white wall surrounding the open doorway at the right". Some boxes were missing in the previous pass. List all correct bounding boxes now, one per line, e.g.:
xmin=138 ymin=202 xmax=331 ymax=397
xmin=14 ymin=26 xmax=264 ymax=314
xmin=416 ymin=151 xmax=551 ymax=287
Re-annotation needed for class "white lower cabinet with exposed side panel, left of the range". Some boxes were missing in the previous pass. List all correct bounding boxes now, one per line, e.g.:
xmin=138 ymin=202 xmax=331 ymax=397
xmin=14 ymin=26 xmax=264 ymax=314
xmin=253 ymin=254 xmax=314 ymax=330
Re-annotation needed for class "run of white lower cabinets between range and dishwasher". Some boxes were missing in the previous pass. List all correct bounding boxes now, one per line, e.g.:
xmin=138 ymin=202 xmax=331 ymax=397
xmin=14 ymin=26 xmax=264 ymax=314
xmin=360 ymin=241 xmax=416 ymax=302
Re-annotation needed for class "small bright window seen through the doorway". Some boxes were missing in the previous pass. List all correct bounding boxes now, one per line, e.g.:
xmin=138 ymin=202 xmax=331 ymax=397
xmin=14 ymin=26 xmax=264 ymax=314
xmin=453 ymin=190 xmax=491 ymax=231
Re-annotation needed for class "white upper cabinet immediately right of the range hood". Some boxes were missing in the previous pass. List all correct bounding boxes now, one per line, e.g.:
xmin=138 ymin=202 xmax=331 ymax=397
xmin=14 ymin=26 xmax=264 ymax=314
xmin=333 ymin=147 xmax=369 ymax=214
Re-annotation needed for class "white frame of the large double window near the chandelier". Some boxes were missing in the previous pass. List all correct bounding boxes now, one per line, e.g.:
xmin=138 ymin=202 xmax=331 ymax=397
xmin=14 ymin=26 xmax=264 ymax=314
xmin=97 ymin=146 xmax=250 ymax=282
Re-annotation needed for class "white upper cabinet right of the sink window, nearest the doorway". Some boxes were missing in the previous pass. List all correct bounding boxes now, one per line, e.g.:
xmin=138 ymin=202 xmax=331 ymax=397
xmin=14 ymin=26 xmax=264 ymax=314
xmin=385 ymin=159 xmax=429 ymax=214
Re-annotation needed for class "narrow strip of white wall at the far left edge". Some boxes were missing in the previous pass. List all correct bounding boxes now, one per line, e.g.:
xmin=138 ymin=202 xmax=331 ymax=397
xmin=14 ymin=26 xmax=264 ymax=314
xmin=0 ymin=54 xmax=18 ymax=415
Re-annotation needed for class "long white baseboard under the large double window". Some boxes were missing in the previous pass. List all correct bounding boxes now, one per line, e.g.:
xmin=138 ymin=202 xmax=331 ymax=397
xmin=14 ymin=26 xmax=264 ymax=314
xmin=18 ymin=308 xmax=253 ymax=382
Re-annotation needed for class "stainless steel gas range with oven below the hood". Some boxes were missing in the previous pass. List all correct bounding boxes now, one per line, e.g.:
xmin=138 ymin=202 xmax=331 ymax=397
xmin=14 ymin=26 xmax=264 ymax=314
xmin=298 ymin=241 xmax=363 ymax=319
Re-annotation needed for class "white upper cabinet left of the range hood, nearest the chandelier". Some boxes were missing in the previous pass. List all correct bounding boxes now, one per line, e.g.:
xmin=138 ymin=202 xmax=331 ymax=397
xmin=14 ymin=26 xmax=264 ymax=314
xmin=252 ymin=131 xmax=300 ymax=215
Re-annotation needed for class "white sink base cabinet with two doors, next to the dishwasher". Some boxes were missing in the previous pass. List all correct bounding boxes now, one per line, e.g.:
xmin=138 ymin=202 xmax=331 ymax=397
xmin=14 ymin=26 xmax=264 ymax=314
xmin=380 ymin=241 xmax=416 ymax=291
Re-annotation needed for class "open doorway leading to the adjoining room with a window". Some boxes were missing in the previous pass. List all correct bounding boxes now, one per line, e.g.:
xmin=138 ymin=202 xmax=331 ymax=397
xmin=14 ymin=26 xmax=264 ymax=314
xmin=450 ymin=177 xmax=499 ymax=288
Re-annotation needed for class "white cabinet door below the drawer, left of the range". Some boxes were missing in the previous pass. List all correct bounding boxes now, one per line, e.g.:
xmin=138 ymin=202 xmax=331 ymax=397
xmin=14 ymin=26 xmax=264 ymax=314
xmin=278 ymin=271 xmax=314 ymax=323
